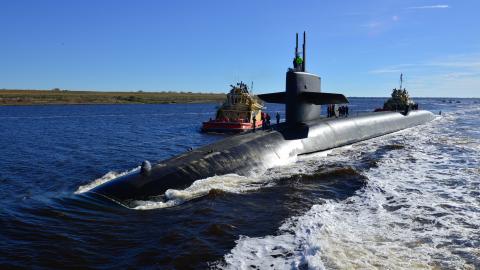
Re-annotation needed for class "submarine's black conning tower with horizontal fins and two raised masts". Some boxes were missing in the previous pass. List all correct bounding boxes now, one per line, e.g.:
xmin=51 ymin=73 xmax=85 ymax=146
xmin=258 ymin=32 xmax=348 ymax=125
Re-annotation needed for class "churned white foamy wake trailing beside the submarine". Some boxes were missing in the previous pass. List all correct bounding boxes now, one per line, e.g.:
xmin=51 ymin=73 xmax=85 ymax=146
xmin=216 ymin=106 xmax=480 ymax=269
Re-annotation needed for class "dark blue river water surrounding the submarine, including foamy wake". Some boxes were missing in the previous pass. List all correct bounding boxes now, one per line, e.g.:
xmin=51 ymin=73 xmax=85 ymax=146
xmin=0 ymin=98 xmax=480 ymax=269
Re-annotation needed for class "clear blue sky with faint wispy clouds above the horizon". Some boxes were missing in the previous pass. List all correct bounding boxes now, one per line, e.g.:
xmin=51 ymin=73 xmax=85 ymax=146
xmin=0 ymin=0 xmax=480 ymax=97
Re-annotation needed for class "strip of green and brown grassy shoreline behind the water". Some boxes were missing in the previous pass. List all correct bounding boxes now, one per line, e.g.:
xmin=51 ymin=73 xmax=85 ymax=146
xmin=0 ymin=88 xmax=225 ymax=105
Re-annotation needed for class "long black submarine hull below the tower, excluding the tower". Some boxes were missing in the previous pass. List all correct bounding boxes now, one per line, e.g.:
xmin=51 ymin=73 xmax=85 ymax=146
xmin=89 ymin=110 xmax=435 ymax=202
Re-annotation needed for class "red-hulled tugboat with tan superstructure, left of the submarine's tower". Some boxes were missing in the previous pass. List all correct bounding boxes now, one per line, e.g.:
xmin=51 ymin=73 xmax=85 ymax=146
xmin=202 ymin=82 xmax=265 ymax=133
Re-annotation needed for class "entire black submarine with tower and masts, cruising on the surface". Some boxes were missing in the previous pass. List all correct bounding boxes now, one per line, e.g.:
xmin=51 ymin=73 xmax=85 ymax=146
xmin=87 ymin=32 xmax=435 ymax=202
